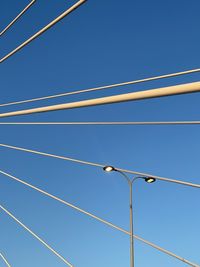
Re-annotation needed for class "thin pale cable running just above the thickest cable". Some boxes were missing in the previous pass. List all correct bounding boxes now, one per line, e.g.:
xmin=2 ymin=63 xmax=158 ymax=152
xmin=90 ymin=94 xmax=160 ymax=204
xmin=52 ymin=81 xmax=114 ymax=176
xmin=0 ymin=69 xmax=200 ymax=107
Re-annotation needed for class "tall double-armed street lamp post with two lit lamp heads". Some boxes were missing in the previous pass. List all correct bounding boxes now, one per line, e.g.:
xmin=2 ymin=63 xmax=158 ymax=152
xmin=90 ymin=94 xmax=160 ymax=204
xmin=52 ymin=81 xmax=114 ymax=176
xmin=103 ymin=166 xmax=156 ymax=267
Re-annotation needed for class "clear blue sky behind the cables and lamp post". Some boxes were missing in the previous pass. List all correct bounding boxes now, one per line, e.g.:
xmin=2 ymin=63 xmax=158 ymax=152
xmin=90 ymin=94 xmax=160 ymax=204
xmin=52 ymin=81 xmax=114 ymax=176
xmin=0 ymin=0 xmax=200 ymax=267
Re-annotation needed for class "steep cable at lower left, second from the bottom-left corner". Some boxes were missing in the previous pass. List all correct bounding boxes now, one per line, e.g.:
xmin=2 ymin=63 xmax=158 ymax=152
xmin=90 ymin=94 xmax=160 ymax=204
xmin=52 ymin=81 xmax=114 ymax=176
xmin=0 ymin=205 xmax=73 ymax=267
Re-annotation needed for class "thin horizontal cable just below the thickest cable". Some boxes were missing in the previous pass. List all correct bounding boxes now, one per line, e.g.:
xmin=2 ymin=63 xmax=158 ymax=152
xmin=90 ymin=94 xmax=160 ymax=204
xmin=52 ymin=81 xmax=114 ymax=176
xmin=0 ymin=121 xmax=200 ymax=126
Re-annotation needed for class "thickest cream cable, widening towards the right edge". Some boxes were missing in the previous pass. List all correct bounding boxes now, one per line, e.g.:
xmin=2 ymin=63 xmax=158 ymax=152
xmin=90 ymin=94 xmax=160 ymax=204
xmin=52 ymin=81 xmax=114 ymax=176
xmin=0 ymin=82 xmax=200 ymax=118
